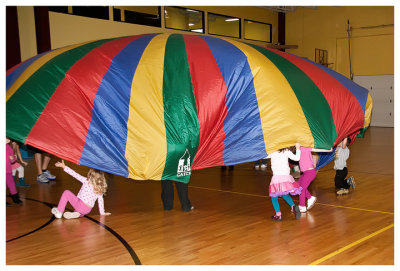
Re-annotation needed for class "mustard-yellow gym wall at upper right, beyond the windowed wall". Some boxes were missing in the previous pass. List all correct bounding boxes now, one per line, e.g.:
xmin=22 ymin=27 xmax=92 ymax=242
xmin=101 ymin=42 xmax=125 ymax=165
xmin=286 ymin=6 xmax=394 ymax=77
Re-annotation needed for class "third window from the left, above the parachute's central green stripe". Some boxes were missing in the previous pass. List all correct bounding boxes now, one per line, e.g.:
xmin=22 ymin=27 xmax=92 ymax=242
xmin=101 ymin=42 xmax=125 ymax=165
xmin=164 ymin=7 xmax=204 ymax=33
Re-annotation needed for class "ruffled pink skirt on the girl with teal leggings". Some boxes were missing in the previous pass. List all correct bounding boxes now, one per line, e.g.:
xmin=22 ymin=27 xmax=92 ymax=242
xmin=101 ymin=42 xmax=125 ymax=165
xmin=269 ymin=175 xmax=303 ymax=197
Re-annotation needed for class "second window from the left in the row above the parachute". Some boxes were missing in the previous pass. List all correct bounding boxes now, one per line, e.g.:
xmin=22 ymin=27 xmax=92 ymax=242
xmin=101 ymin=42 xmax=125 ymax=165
xmin=113 ymin=6 xmax=161 ymax=27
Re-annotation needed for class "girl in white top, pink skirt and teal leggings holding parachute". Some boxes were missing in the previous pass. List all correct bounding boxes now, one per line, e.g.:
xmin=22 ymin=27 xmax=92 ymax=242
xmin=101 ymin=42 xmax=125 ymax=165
xmin=268 ymin=143 xmax=301 ymax=221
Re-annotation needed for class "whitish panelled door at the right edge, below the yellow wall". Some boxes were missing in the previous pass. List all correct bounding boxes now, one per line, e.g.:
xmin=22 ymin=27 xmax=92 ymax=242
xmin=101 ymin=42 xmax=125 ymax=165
xmin=354 ymin=75 xmax=394 ymax=127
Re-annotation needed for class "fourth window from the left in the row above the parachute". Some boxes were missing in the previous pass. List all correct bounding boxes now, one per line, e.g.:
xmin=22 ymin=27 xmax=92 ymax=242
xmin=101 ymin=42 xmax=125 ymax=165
xmin=208 ymin=13 xmax=240 ymax=38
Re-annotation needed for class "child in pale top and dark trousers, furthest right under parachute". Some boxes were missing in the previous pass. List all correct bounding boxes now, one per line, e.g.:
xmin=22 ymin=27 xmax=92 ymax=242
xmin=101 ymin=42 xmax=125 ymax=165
xmin=333 ymin=137 xmax=356 ymax=195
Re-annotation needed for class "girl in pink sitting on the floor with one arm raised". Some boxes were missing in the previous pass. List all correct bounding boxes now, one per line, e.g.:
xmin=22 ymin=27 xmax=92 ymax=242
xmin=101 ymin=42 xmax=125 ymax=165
xmin=51 ymin=160 xmax=111 ymax=219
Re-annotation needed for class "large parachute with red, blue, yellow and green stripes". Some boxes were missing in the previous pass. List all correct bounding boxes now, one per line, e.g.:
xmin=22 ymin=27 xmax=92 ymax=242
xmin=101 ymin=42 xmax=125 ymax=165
xmin=6 ymin=34 xmax=372 ymax=182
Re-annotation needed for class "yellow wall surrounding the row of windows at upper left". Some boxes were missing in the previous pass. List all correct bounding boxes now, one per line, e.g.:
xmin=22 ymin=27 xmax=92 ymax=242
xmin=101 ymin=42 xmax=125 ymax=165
xmin=18 ymin=6 xmax=278 ymax=61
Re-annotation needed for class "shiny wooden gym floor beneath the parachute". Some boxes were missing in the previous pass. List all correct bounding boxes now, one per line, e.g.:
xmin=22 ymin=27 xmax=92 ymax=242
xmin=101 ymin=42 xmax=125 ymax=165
xmin=6 ymin=127 xmax=394 ymax=265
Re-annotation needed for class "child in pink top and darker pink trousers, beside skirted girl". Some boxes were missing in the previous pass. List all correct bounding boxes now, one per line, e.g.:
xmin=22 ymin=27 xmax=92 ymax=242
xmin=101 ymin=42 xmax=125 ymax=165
xmin=299 ymin=147 xmax=332 ymax=213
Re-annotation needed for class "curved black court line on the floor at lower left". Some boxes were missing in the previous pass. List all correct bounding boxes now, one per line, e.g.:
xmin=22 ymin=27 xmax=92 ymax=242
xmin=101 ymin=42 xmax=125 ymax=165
xmin=6 ymin=198 xmax=142 ymax=265
